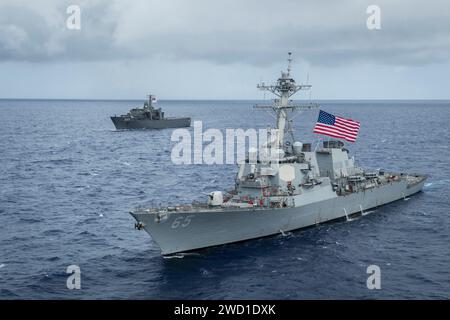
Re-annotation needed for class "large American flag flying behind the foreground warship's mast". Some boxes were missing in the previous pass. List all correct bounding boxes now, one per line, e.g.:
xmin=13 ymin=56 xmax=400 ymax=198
xmin=314 ymin=110 xmax=360 ymax=142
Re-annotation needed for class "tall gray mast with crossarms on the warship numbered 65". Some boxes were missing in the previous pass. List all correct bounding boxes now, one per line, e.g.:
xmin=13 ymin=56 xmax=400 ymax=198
xmin=255 ymin=52 xmax=318 ymax=148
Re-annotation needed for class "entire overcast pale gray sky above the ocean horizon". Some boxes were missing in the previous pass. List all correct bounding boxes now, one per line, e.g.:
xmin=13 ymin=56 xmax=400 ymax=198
xmin=0 ymin=0 xmax=450 ymax=99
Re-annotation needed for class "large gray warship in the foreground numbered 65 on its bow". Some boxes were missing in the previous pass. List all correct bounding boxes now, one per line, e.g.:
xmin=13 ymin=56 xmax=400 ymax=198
xmin=130 ymin=55 xmax=426 ymax=255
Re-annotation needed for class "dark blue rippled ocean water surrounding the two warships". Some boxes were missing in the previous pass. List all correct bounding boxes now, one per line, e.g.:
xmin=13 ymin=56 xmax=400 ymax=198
xmin=0 ymin=100 xmax=450 ymax=299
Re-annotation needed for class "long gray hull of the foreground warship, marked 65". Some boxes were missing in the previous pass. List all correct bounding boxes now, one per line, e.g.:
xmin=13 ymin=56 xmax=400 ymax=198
xmin=130 ymin=176 xmax=426 ymax=255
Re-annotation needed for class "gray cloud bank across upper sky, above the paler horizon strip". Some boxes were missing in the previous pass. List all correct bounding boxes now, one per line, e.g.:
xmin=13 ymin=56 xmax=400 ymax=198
xmin=0 ymin=0 xmax=450 ymax=66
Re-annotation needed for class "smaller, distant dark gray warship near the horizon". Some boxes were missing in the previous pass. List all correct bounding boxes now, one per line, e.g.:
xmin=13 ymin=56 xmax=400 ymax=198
xmin=111 ymin=95 xmax=191 ymax=130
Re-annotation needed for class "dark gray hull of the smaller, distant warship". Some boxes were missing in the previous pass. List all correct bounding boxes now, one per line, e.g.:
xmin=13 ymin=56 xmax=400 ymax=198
xmin=111 ymin=117 xmax=191 ymax=130
